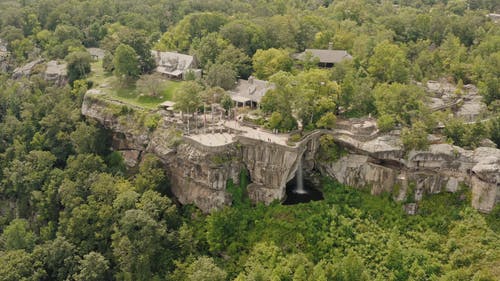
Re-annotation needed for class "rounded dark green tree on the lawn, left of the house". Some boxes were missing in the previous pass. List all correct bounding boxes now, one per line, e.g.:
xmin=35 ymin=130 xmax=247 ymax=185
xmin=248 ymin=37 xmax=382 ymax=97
xmin=113 ymin=44 xmax=139 ymax=79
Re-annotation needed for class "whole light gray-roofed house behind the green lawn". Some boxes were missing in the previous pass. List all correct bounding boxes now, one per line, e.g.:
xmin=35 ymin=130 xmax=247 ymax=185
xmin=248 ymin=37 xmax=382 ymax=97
xmin=151 ymin=51 xmax=201 ymax=79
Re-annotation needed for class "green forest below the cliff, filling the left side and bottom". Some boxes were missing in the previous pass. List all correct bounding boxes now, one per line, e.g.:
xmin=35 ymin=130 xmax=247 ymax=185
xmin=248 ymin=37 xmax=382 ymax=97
xmin=0 ymin=77 xmax=500 ymax=280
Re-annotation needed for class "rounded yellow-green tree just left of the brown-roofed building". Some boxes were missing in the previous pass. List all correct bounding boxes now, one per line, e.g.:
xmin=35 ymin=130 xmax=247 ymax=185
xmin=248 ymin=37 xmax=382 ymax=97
xmin=252 ymin=48 xmax=293 ymax=79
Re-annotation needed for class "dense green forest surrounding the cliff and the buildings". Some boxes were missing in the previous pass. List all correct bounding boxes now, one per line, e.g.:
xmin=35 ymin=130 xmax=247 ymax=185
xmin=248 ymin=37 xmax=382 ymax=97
xmin=0 ymin=0 xmax=500 ymax=281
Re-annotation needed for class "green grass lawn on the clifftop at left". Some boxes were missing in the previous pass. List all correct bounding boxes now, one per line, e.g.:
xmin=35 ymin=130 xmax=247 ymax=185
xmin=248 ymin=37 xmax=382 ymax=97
xmin=89 ymin=61 xmax=183 ymax=109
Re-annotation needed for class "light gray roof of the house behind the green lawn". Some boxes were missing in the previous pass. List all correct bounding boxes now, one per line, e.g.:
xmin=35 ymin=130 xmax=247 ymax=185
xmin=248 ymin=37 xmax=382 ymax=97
xmin=151 ymin=51 xmax=196 ymax=76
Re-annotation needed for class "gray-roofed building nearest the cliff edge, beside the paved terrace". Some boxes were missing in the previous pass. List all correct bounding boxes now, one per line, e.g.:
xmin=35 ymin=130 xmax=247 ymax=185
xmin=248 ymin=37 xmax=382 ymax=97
xmin=229 ymin=76 xmax=274 ymax=108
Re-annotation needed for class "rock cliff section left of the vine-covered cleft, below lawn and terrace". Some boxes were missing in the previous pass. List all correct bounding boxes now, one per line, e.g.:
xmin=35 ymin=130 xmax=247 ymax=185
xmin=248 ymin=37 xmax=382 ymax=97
xmin=82 ymin=94 xmax=242 ymax=212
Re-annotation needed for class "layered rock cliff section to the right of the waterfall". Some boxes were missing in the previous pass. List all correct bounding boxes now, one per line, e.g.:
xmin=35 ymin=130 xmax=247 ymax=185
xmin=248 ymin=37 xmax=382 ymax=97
xmin=318 ymin=132 xmax=500 ymax=212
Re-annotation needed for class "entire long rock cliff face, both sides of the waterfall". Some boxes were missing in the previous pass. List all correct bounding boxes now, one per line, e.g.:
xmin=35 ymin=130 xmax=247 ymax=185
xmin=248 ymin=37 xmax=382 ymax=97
xmin=82 ymin=90 xmax=500 ymax=213
